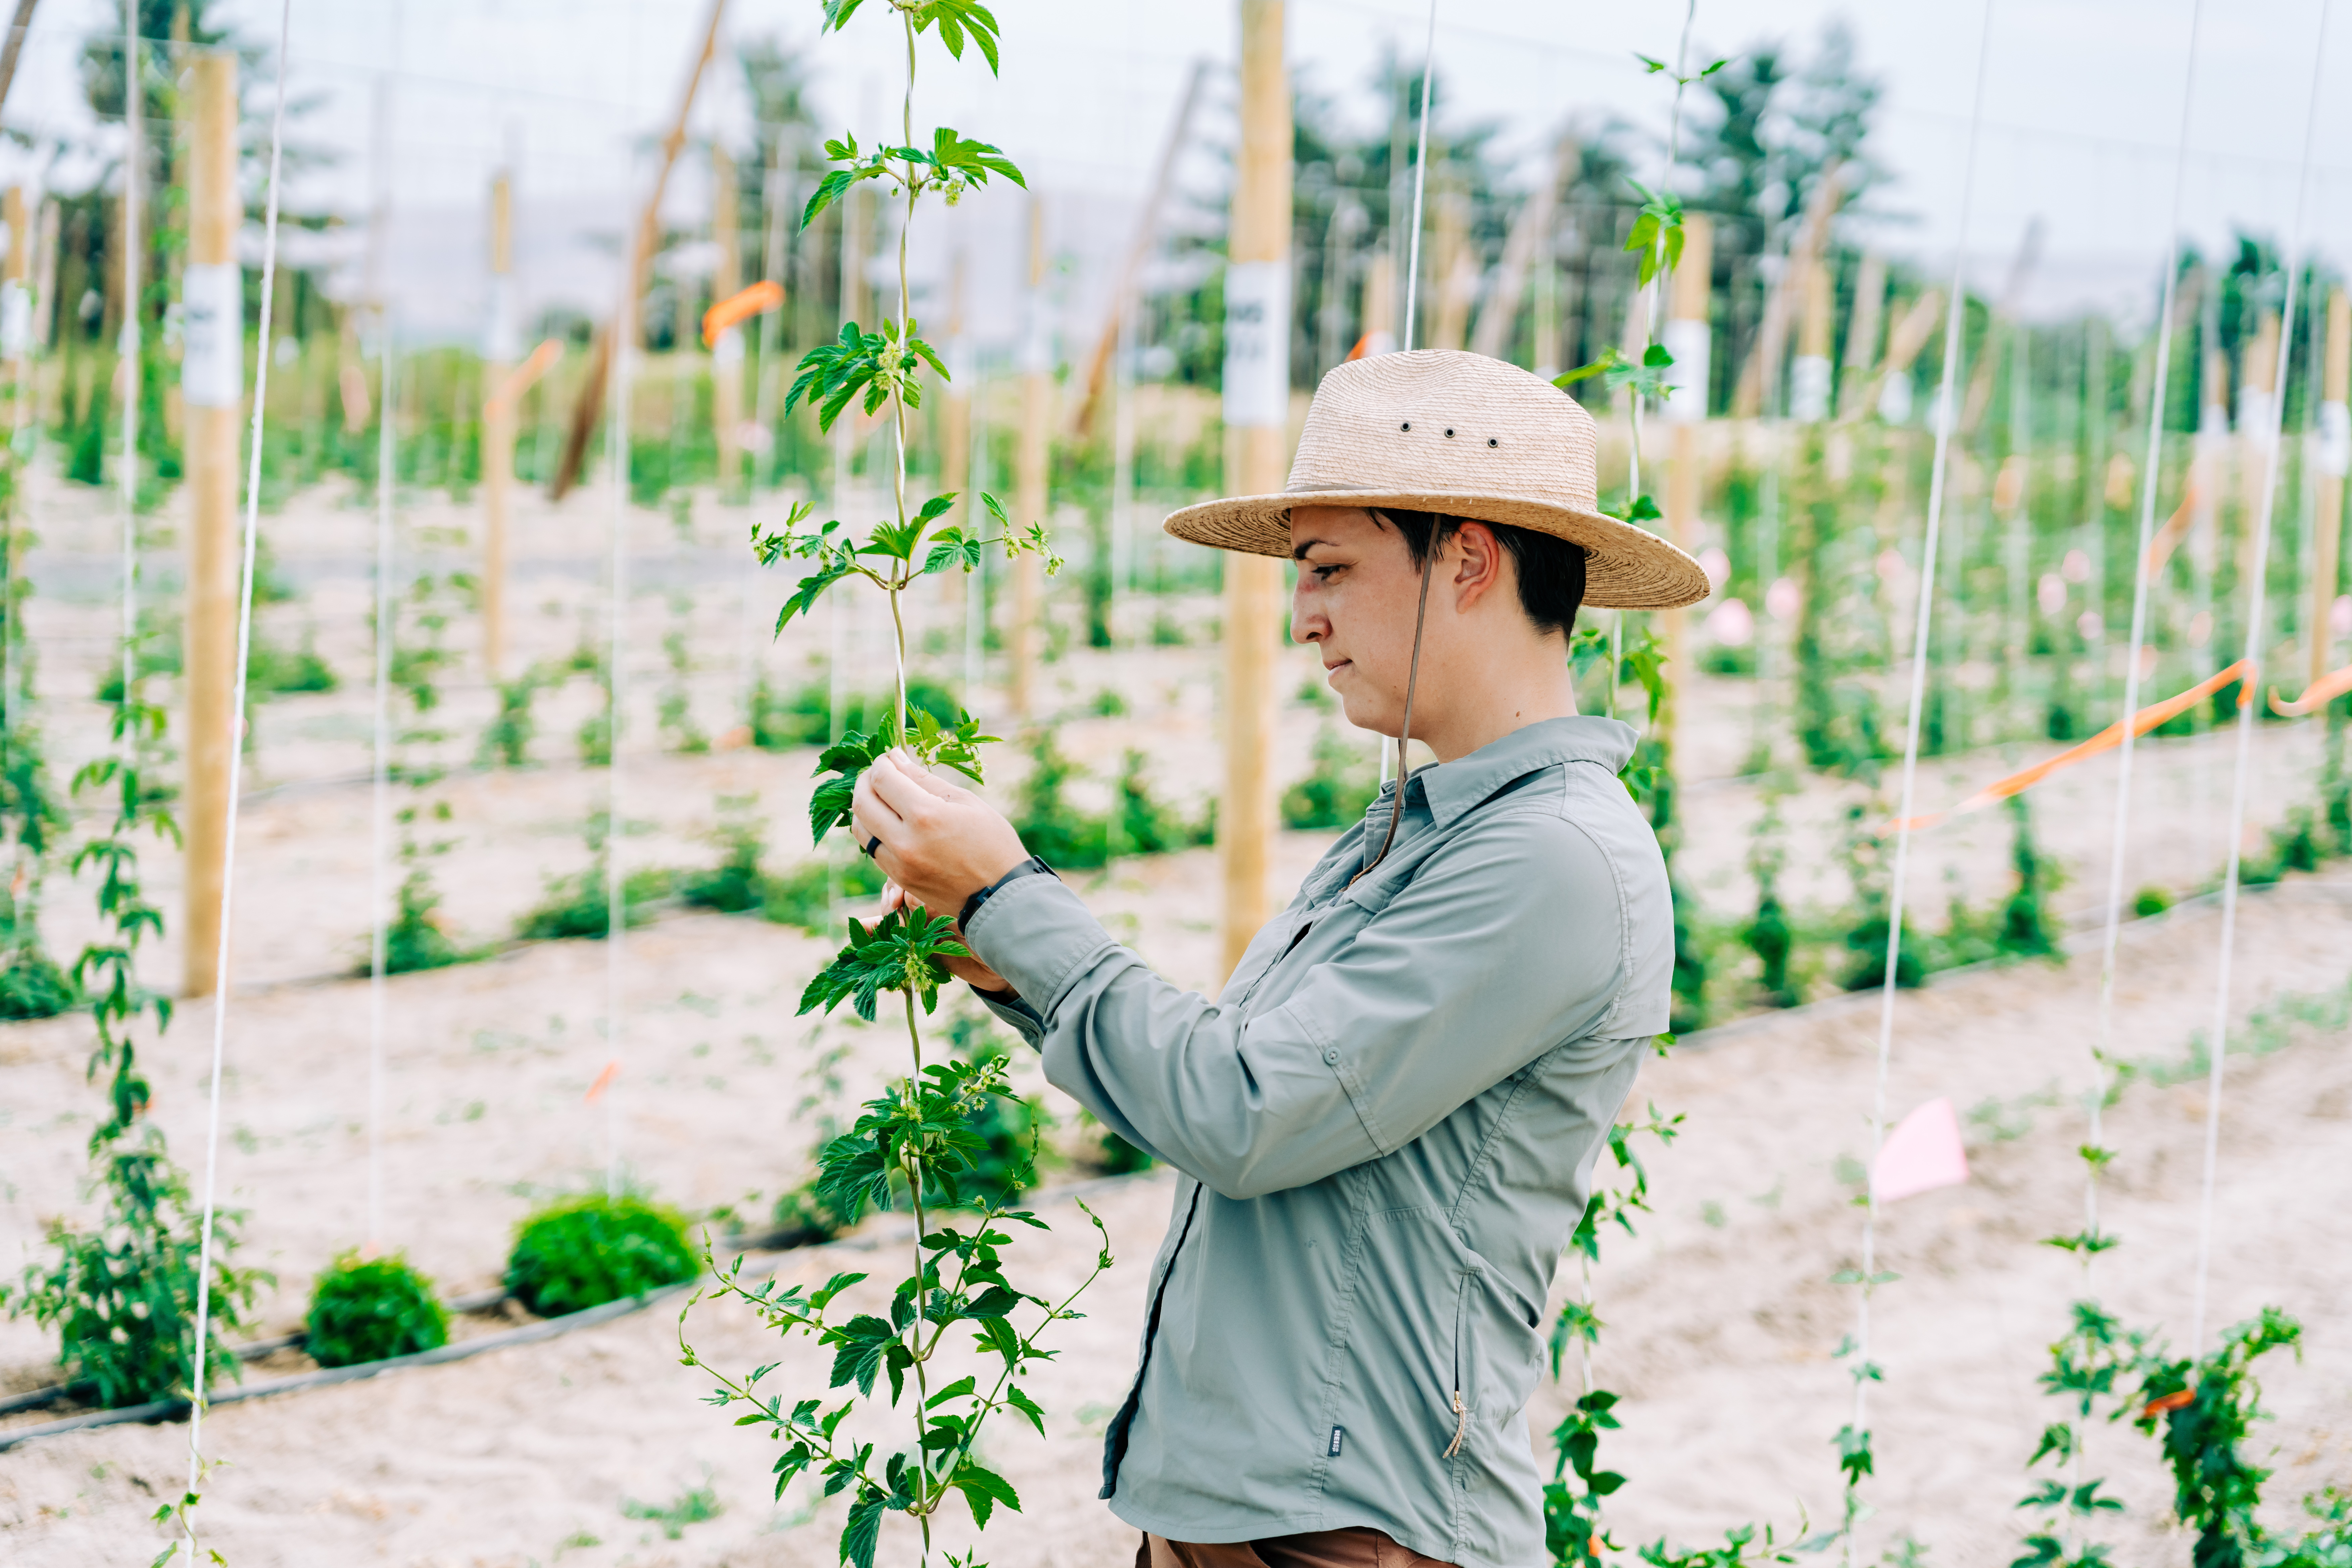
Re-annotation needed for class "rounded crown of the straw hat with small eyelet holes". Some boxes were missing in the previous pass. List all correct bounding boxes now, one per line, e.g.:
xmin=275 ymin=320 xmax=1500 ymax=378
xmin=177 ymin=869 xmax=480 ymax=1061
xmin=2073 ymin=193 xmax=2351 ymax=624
xmin=1284 ymin=348 xmax=1599 ymax=512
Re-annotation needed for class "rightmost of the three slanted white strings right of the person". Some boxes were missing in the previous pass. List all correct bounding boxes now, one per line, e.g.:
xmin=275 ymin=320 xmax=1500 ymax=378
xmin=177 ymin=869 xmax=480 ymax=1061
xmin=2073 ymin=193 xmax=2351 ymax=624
xmin=2190 ymin=0 xmax=2329 ymax=1357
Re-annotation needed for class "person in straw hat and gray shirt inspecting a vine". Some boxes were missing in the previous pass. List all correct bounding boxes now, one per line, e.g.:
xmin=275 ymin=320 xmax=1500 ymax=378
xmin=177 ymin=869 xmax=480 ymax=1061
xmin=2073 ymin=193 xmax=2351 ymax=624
xmin=851 ymin=350 xmax=1708 ymax=1568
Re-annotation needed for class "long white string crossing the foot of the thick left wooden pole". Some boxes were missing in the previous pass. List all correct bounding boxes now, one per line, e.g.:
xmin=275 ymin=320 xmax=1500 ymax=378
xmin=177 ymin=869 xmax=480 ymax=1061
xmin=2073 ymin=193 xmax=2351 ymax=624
xmin=187 ymin=0 xmax=294 ymax=1563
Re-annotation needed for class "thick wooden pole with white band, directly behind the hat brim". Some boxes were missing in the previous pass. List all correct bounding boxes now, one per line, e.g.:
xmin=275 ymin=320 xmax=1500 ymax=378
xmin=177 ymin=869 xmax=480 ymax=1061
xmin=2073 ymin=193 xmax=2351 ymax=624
xmin=1216 ymin=0 xmax=1298 ymax=973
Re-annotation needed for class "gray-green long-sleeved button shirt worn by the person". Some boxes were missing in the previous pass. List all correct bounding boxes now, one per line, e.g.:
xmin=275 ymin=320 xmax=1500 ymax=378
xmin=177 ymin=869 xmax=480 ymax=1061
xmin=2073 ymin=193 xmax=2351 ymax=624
xmin=967 ymin=717 xmax=1675 ymax=1568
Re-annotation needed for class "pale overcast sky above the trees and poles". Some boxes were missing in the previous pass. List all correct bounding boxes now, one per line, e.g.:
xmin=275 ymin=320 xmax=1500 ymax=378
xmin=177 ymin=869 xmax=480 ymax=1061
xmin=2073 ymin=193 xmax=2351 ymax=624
xmin=0 ymin=0 xmax=2352 ymax=338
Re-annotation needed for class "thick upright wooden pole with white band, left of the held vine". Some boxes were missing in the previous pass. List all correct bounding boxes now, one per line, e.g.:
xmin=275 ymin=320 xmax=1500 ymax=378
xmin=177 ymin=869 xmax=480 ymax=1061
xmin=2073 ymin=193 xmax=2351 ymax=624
xmin=181 ymin=52 xmax=245 ymax=997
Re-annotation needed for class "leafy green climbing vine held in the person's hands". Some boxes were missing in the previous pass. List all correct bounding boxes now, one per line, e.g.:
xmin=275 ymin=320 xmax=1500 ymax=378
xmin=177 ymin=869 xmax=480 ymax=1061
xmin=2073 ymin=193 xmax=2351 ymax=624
xmin=680 ymin=0 xmax=1091 ymax=1568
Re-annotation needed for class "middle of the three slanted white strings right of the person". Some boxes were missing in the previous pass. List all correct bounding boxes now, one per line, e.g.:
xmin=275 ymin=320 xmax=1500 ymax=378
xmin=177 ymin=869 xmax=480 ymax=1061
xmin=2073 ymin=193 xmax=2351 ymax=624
xmin=2081 ymin=0 xmax=2204 ymax=1281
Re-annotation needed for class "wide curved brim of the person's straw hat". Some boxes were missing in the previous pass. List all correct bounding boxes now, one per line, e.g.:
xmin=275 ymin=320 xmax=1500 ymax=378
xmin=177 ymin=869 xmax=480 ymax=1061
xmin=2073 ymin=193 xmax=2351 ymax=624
xmin=1162 ymin=489 xmax=1712 ymax=609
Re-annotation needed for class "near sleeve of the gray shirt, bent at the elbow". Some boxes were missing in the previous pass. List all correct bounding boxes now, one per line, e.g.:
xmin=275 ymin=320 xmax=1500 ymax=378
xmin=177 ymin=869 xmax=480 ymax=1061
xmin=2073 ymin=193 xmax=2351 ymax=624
xmin=967 ymin=811 xmax=1630 ymax=1199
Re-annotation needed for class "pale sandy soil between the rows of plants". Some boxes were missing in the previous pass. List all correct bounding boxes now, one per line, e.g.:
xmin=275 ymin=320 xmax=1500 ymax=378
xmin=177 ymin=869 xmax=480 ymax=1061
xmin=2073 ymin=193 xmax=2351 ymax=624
xmin=0 ymin=472 xmax=2352 ymax=1568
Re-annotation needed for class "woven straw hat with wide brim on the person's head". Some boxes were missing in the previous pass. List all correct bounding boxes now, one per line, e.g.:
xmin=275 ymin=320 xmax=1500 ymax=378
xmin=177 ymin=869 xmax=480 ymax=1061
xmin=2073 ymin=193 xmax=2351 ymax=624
xmin=1167 ymin=348 xmax=1708 ymax=609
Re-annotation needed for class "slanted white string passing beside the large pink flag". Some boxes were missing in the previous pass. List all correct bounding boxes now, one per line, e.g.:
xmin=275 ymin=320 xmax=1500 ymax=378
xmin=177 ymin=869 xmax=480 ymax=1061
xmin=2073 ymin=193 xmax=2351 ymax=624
xmin=1839 ymin=0 xmax=1992 ymax=1568
